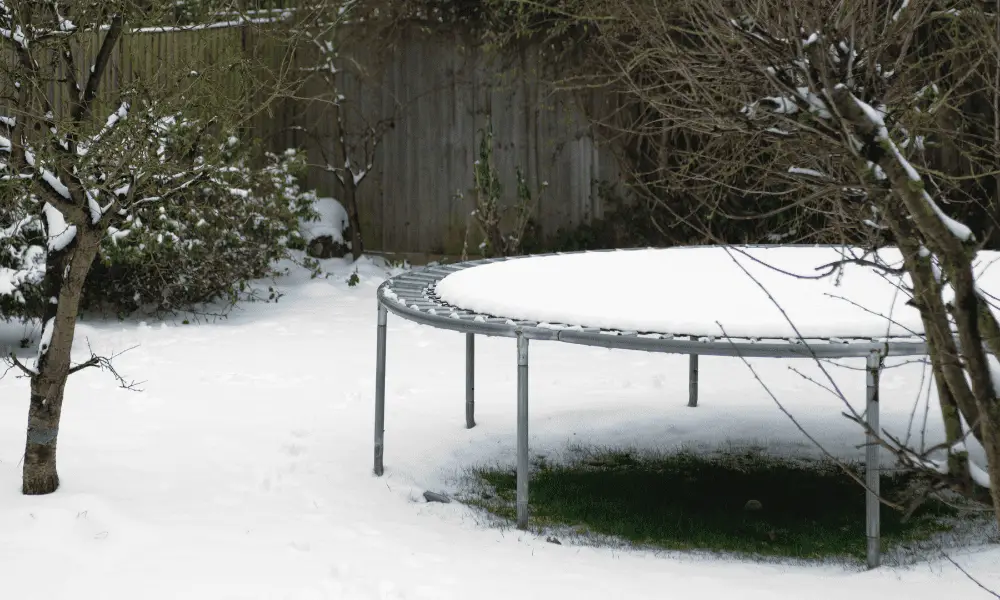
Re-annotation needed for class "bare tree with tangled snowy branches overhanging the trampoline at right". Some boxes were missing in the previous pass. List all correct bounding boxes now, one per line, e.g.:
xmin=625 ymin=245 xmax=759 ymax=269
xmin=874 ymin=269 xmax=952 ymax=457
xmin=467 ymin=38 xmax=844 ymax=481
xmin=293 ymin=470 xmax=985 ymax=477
xmin=524 ymin=0 xmax=1000 ymax=520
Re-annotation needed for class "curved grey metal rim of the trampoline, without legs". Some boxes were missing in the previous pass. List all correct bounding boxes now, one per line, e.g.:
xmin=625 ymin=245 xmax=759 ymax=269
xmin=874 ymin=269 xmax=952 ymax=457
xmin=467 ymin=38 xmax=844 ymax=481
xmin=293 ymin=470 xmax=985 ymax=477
xmin=377 ymin=244 xmax=927 ymax=358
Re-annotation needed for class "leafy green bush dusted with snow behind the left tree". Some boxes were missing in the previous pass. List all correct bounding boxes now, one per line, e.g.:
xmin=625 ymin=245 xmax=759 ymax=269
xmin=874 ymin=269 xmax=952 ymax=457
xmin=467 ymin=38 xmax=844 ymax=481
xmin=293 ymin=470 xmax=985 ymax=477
xmin=83 ymin=123 xmax=316 ymax=314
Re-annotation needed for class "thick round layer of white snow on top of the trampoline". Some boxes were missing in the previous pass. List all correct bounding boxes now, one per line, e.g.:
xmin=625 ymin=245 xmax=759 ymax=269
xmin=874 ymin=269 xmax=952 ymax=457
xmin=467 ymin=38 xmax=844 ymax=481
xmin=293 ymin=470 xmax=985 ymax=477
xmin=437 ymin=247 xmax=1000 ymax=339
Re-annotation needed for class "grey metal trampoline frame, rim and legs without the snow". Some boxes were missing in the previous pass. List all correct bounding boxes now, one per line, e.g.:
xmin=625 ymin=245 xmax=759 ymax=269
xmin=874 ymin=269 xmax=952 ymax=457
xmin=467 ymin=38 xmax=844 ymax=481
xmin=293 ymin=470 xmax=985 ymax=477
xmin=374 ymin=249 xmax=927 ymax=568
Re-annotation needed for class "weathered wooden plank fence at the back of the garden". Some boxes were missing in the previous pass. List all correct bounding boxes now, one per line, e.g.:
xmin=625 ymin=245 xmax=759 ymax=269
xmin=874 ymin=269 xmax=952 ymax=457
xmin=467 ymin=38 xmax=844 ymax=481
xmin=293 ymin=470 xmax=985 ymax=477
xmin=0 ymin=21 xmax=618 ymax=254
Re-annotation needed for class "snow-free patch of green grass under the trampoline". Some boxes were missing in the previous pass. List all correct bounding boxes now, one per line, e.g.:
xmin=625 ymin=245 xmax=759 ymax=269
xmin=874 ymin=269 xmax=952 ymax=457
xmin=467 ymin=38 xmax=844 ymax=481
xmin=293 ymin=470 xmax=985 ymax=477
xmin=467 ymin=451 xmax=958 ymax=559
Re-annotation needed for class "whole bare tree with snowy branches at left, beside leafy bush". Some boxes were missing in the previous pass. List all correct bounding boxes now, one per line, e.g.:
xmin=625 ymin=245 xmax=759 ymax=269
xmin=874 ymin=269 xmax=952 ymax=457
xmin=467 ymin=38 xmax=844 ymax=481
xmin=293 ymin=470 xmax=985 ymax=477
xmin=0 ymin=0 xmax=314 ymax=494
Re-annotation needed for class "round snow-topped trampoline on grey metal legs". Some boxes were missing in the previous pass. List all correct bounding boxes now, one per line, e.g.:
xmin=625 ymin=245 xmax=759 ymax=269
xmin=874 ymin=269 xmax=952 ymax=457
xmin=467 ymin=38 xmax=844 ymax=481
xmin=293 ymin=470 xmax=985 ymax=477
xmin=374 ymin=246 xmax=927 ymax=568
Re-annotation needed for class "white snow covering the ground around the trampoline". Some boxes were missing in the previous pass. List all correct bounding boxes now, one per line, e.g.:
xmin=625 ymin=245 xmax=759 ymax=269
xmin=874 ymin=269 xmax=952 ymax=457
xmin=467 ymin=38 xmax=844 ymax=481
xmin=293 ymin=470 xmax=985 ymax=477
xmin=0 ymin=255 xmax=1000 ymax=600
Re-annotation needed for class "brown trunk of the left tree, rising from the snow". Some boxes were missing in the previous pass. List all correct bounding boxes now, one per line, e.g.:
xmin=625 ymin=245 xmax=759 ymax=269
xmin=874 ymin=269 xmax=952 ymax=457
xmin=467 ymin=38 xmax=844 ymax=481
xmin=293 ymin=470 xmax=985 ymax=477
xmin=21 ymin=225 xmax=100 ymax=495
